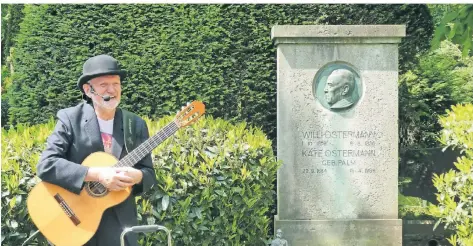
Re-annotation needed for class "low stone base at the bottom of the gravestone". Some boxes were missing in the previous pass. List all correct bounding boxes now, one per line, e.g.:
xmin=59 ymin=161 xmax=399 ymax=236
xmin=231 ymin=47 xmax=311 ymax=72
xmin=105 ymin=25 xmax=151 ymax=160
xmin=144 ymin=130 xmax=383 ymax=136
xmin=274 ymin=215 xmax=402 ymax=246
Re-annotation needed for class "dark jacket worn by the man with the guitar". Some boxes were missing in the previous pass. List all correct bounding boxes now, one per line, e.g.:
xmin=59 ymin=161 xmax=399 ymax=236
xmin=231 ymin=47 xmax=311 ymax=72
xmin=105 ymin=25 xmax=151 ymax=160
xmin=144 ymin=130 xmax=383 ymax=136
xmin=37 ymin=103 xmax=156 ymax=246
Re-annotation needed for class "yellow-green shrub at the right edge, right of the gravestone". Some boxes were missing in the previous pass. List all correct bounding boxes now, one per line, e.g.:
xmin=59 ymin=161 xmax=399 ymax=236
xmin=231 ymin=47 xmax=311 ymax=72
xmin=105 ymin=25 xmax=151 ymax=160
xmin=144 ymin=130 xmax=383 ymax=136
xmin=429 ymin=104 xmax=473 ymax=246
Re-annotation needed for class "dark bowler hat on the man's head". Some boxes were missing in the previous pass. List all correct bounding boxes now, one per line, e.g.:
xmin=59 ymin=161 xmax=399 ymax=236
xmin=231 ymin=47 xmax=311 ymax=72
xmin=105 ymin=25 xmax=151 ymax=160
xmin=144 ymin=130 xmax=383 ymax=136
xmin=77 ymin=55 xmax=126 ymax=93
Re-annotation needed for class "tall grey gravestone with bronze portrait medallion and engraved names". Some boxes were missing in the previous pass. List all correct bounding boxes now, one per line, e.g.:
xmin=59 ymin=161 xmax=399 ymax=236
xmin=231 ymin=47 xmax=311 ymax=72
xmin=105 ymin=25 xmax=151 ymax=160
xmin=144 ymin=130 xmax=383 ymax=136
xmin=271 ymin=25 xmax=405 ymax=246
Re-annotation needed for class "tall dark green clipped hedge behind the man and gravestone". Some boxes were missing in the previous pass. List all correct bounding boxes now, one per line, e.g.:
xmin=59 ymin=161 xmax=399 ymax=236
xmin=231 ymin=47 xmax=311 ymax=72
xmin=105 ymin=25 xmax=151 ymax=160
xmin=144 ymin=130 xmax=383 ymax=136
xmin=8 ymin=4 xmax=433 ymax=139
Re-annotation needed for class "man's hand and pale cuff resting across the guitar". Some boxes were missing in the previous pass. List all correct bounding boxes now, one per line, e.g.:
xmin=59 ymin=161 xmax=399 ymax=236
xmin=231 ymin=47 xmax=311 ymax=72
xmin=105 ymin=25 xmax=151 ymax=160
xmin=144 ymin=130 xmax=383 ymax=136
xmin=85 ymin=167 xmax=134 ymax=191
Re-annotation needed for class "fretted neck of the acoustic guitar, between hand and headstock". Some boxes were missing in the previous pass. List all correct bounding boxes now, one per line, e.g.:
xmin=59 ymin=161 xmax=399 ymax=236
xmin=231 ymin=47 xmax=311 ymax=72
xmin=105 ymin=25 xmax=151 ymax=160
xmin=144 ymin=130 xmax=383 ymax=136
xmin=115 ymin=121 xmax=179 ymax=167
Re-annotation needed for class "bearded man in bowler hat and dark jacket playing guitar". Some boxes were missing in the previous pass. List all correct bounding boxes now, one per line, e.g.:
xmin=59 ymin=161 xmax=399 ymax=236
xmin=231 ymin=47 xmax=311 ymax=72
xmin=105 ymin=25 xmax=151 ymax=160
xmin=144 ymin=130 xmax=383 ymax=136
xmin=37 ymin=55 xmax=156 ymax=246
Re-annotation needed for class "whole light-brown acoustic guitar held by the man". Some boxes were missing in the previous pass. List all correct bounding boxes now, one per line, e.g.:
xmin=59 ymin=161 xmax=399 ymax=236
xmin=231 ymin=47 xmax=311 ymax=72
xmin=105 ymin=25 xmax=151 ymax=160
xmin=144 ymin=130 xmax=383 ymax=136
xmin=27 ymin=101 xmax=205 ymax=246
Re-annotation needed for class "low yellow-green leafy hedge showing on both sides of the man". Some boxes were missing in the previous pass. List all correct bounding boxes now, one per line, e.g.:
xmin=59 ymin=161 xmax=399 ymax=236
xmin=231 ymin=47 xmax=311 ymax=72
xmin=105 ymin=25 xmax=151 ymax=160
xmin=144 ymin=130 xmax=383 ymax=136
xmin=1 ymin=117 xmax=278 ymax=246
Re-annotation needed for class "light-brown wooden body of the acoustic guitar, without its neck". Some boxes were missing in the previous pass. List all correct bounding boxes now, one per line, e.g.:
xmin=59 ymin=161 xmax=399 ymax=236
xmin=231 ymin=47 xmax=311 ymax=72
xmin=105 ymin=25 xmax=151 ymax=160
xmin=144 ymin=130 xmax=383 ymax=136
xmin=27 ymin=152 xmax=131 ymax=246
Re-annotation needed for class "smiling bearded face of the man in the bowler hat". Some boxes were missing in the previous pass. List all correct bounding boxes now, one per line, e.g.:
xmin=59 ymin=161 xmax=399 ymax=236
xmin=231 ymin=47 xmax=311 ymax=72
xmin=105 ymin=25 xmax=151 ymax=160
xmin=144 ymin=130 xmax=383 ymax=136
xmin=83 ymin=75 xmax=122 ymax=110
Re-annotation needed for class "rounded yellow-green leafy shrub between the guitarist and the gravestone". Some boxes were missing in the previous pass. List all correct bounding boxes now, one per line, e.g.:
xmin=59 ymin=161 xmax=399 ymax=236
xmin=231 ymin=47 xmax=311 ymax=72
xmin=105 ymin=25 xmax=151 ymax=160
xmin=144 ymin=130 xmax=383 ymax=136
xmin=138 ymin=117 xmax=278 ymax=245
